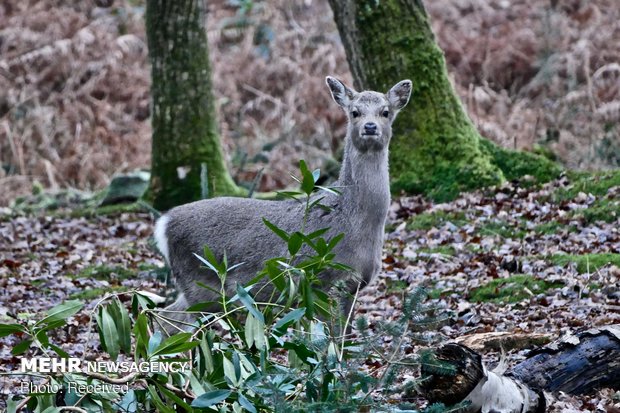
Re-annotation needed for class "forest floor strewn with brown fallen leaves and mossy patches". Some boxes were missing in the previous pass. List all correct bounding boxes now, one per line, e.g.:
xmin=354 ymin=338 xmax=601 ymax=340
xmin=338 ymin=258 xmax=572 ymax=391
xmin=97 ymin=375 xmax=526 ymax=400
xmin=0 ymin=172 xmax=620 ymax=412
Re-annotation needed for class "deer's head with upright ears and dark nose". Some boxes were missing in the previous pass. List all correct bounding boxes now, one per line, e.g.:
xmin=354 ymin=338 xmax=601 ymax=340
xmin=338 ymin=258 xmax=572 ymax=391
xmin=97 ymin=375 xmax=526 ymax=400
xmin=325 ymin=76 xmax=411 ymax=153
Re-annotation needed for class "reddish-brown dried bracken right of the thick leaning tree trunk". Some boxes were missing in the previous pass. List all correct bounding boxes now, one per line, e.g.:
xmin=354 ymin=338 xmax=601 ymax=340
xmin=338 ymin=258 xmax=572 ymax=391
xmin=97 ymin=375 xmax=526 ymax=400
xmin=427 ymin=0 xmax=620 ymax=169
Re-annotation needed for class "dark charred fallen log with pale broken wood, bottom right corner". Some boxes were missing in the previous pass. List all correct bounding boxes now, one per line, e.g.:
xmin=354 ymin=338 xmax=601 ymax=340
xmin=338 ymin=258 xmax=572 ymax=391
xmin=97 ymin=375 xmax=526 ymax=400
xmin=420 ymin=324 xmax=620 ymax=413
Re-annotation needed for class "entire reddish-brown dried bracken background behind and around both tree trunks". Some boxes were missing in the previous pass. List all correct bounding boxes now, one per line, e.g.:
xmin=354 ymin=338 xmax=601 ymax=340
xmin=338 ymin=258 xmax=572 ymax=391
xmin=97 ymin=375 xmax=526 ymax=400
xmin=0 ymin=0 xmax=620 ymax=205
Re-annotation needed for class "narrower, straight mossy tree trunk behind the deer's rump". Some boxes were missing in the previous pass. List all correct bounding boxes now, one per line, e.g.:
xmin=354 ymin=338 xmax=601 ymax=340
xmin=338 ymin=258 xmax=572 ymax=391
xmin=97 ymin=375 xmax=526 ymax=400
xmin=146 ymin=0 xmax=240 ymax=210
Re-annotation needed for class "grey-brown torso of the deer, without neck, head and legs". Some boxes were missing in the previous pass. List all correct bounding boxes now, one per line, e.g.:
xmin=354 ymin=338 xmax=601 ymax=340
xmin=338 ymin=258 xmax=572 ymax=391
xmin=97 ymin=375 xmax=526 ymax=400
xmin=156 ymin=197 xmax=383 ymax=304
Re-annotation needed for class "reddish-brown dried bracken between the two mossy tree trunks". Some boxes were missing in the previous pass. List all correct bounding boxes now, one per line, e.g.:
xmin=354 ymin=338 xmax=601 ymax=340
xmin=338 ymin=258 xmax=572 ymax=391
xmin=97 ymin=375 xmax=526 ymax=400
xmin=207 ymin=0 xmax=350 ymax=190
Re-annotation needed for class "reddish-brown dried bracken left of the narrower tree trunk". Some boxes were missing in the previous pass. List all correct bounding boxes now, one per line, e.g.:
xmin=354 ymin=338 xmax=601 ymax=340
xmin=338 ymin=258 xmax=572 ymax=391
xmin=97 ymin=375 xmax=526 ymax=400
xmin=0 ymin=0 xmax=150 ymax=203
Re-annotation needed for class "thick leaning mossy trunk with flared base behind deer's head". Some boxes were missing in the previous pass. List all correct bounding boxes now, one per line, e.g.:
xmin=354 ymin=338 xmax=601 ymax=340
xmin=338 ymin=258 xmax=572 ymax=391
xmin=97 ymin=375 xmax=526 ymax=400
xmin=329 ymin=0 xmax=559 ymax=200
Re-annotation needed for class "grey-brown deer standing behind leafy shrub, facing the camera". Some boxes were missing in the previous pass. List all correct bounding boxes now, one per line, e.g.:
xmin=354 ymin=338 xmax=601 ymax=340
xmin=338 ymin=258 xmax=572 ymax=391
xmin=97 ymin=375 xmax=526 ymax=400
xmin=154 ymin=76 xmax=412 ymax=330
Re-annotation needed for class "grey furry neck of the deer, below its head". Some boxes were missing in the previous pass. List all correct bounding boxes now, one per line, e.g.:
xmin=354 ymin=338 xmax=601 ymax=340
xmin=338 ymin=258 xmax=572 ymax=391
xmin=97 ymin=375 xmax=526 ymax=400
xmin=338 ymin=140 xmax=390 ymax=222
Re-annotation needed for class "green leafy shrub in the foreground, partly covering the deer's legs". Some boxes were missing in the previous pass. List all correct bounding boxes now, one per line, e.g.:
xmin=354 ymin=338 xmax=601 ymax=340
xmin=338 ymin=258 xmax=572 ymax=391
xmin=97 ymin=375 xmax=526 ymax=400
xmin=0 ymin=161 xmax=452 ymax=413
